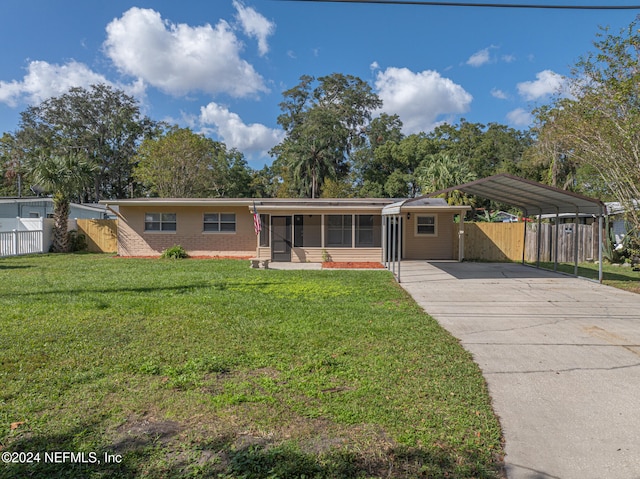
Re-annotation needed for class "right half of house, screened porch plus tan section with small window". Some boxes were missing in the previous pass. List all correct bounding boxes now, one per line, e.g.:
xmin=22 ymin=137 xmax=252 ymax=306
xmin=256 ymin=198 xmax=469 ymax=264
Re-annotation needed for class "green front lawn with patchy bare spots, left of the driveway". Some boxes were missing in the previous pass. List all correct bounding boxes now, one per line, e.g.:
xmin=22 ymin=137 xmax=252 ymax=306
xmin=0 ymin=254 xmax=502 ymax=478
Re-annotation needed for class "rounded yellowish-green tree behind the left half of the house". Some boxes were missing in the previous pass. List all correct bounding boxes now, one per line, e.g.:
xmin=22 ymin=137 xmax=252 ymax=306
xmin=134 ymin=126 xmax=252 ymax=198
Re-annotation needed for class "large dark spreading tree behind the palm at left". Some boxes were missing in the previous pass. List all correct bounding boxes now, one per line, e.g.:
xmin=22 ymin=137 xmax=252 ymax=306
xmin=16 ymin=84 xmax=157 ymax=201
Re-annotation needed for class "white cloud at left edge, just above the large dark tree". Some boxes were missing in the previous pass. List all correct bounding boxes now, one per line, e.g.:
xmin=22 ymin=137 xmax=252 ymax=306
xmin=0 ymin=61 xmax=131 ymax=107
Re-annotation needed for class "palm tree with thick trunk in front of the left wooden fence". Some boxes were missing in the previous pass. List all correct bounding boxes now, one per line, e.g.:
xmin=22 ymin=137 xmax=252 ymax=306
xmin=31 ymin=154 xmax=97 ymax=253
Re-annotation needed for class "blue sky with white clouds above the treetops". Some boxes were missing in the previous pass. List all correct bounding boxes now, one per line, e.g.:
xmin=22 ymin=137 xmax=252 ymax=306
xmin=0 ymin=0 xmax=640 ymax=168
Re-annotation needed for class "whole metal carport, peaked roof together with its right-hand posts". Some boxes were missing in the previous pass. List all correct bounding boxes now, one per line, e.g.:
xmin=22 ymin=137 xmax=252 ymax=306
xmin=426 ymin=173 xmax=607 ymax=282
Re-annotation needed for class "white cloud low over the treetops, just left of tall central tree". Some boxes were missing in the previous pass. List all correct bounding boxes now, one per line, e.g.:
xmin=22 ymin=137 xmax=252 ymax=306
xmin=200 ymin=102 xmax=284 ymax=153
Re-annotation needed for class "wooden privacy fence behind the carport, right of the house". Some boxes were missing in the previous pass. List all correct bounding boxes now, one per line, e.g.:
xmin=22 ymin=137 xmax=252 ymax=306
xmin=464 ymin=223 xmax=598 ymax=263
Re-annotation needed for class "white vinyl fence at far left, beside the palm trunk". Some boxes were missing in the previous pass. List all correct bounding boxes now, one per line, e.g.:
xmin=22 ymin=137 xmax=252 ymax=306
xmin=0 ymin=218 xmax=52 ymax=257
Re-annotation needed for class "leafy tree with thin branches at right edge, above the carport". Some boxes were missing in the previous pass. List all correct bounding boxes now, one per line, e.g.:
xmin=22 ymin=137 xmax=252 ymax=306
xmin=538 ymin=17 xmax=640 ymax=238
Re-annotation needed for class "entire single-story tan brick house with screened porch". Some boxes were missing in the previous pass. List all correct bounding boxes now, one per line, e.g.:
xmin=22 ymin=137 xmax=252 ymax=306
xmin=101 ymin=198 xmax=470 ymax=262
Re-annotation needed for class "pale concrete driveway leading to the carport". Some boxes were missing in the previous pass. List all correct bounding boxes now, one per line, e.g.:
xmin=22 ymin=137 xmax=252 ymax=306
xmin=402 ymin=261 xmax=640 ymax=479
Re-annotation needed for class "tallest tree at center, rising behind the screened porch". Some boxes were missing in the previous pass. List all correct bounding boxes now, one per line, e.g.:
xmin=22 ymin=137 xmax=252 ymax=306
xmin=271 ymin=73 xmax=382 ymax=197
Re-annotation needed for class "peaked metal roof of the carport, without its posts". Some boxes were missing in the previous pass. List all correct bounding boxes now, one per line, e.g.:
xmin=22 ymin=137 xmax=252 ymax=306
xmin=418 ymin=173 xmax=606 ymax=216
